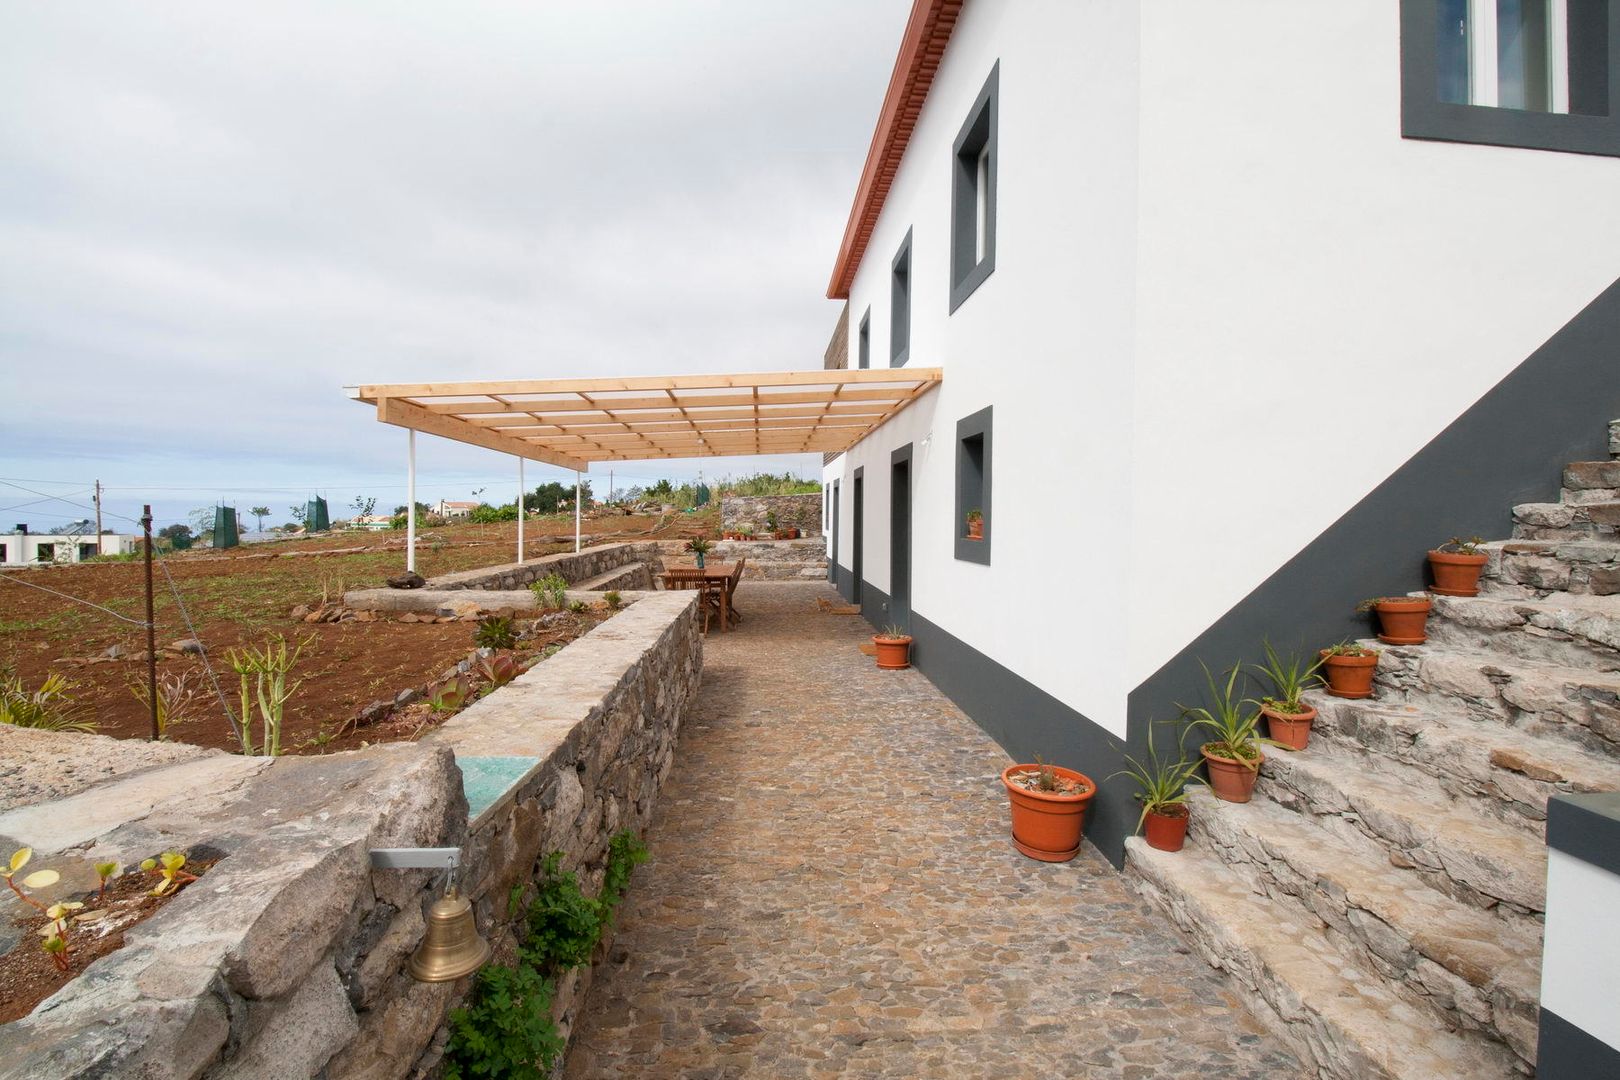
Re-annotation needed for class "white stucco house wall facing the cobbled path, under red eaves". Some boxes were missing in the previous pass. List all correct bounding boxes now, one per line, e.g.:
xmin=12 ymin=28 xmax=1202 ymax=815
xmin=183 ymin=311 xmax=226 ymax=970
xmin=828 ymin=0 xmax=1137 ymax=730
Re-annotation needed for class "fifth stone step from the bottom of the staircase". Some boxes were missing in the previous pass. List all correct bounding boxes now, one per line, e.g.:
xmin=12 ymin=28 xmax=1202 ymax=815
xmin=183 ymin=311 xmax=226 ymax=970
xmin=1374 ymin=644 xmax=1620 ymax=759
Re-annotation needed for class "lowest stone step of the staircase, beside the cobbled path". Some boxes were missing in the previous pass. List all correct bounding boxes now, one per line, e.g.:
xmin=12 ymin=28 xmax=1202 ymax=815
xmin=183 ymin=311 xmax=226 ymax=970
xmin=1126 ymin=837 xmax=1520 ymax=1080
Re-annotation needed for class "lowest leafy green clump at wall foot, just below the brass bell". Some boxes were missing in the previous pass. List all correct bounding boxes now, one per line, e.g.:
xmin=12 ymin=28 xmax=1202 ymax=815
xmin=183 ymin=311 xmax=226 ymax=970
xmin=444 ymin=960 xmax=562 ymax=1080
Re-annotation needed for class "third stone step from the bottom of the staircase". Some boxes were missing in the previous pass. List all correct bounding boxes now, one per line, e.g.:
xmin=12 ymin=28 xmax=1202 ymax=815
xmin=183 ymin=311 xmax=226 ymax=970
xmin=1256 ymin=740 xmax=1547 ymax=921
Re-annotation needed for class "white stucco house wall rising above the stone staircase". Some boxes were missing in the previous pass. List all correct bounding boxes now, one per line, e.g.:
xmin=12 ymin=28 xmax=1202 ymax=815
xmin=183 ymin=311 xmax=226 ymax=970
xmin=1129 ymin=0 xmax=1620 ymax=682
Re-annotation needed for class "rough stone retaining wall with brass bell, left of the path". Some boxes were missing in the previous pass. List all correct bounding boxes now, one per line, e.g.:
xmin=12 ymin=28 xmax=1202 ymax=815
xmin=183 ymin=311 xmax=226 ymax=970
xmin=0 ymin=593 xmax=703 ymax=1080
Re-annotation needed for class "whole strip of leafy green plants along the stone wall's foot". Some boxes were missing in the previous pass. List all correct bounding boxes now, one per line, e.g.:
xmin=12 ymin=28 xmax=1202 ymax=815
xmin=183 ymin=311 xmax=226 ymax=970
xmin=444 ymin=831 xmax=646 ymax=1080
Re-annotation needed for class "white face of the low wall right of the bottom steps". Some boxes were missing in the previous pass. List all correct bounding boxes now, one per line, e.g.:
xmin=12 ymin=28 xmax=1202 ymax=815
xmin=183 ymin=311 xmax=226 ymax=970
xmin=1541 ymin=848 xmax=1620 ymax=1049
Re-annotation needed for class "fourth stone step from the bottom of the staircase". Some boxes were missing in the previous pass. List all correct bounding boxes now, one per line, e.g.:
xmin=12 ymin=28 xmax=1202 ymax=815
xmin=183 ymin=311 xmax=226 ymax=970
xmin=1307 ymin=693 xmax=1620 ymax=822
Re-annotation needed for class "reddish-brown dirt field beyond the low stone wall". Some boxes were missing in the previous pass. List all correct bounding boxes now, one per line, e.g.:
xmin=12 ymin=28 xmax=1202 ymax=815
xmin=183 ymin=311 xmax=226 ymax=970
xmin=0 ymin=508 xmax=718 ymax=753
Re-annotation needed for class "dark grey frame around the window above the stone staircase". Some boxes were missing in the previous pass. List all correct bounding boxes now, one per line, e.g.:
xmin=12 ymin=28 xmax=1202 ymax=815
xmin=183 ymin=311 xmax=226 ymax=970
xmin=1401 ymin=0 xmax=1620 ymax=157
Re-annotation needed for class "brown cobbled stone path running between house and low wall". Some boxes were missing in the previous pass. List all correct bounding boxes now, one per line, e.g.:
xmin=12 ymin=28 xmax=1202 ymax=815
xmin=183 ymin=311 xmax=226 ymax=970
xmin=565 ymin=583 xmax=1301 ymax=1080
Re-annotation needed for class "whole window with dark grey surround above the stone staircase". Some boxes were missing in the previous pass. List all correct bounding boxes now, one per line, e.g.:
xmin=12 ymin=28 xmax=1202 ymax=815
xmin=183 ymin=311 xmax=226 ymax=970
xmin=1401 ymin=0 xmax=1620 ymax=155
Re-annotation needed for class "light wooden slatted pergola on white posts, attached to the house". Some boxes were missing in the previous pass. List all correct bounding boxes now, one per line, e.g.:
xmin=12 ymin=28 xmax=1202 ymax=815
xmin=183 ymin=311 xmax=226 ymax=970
xmin=347 ymin=368 xmax=941 ymax=570
